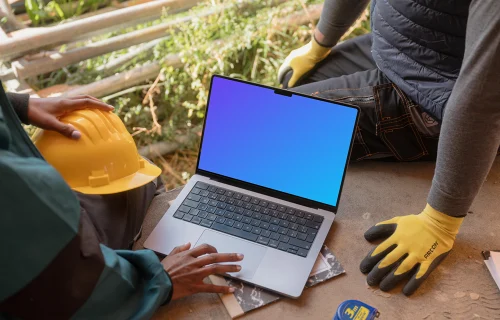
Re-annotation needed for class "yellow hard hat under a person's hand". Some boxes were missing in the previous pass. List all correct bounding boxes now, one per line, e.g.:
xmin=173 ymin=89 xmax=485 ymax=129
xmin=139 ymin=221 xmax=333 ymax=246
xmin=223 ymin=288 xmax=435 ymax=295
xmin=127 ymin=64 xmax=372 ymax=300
xmin=33 ymin=109 xmax=161 ymax=194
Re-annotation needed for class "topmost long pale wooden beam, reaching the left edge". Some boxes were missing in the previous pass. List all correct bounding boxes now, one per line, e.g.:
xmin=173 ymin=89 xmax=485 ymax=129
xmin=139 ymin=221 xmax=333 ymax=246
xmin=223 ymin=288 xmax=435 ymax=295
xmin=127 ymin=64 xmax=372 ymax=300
xmin=0 ymin=0 xmax=198 ymax=58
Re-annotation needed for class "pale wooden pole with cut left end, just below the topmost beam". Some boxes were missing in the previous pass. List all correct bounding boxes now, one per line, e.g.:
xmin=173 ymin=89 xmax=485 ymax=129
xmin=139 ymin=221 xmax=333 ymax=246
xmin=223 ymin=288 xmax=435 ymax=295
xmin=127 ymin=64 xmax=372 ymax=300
xmin=12 ymin=10 xmax=214 ymax=79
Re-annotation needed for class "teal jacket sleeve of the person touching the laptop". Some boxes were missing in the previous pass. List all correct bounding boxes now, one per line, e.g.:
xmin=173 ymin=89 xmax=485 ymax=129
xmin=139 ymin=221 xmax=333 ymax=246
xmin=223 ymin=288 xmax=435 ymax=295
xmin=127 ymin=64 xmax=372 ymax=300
xmin=0 ymin=149 xmax=172 ymax=319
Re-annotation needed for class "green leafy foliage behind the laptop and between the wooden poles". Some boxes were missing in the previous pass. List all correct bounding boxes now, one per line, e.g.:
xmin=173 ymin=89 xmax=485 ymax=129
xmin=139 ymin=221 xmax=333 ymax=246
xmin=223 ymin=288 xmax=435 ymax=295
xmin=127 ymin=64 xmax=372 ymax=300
xmin=31 ymin=0 xmax=369 ymax=149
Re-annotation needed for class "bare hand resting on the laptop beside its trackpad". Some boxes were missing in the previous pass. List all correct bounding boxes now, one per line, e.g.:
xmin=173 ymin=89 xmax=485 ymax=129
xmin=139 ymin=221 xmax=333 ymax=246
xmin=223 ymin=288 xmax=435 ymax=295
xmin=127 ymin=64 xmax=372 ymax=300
xmin=161 ymin=243 xmax=243 ymax=300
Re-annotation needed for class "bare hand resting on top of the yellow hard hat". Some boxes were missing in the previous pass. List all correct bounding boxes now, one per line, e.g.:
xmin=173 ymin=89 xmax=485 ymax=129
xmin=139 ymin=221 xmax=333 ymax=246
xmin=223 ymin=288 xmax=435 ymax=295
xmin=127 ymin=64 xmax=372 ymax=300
xmin=28 ymin=95 xmax=114 ymax=139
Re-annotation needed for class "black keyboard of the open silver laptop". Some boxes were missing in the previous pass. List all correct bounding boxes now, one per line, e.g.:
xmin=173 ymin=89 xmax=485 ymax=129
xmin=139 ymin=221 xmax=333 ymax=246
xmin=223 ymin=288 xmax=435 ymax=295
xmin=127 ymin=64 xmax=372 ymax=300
xmin=174 ymin=182 xmax=323 ymax=257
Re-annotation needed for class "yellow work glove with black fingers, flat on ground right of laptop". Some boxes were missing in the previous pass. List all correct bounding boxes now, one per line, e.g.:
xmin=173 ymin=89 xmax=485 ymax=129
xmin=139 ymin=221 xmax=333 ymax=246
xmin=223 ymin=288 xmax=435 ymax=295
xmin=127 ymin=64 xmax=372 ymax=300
xmin=360 ymin=205 xmax=464 ymax=296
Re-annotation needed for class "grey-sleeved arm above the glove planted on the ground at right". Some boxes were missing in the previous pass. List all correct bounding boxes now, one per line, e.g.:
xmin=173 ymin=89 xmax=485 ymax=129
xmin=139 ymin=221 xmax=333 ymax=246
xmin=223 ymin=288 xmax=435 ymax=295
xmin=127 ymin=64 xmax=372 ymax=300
xmin=428 ymin=0 xmax=500 ymax=217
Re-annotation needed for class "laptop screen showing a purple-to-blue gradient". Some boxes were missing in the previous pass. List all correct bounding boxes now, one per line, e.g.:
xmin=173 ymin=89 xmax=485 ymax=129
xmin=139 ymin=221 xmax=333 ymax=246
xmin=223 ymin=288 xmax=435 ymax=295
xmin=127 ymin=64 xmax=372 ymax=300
xmin=198 ymin=77 xmax=358 ymax=206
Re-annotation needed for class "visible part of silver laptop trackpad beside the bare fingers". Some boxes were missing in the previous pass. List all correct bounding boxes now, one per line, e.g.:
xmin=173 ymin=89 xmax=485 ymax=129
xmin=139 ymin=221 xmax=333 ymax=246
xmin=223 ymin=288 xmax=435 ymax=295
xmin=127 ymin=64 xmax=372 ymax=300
xmin=195 ymin=230 xmax=267 ymax=280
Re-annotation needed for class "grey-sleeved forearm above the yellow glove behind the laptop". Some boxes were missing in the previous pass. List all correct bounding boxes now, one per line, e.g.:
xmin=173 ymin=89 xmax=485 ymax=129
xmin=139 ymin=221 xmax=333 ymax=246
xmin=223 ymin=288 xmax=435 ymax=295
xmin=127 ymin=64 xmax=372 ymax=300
xmin=314 ymin=0 xmax=370 ymax=47
